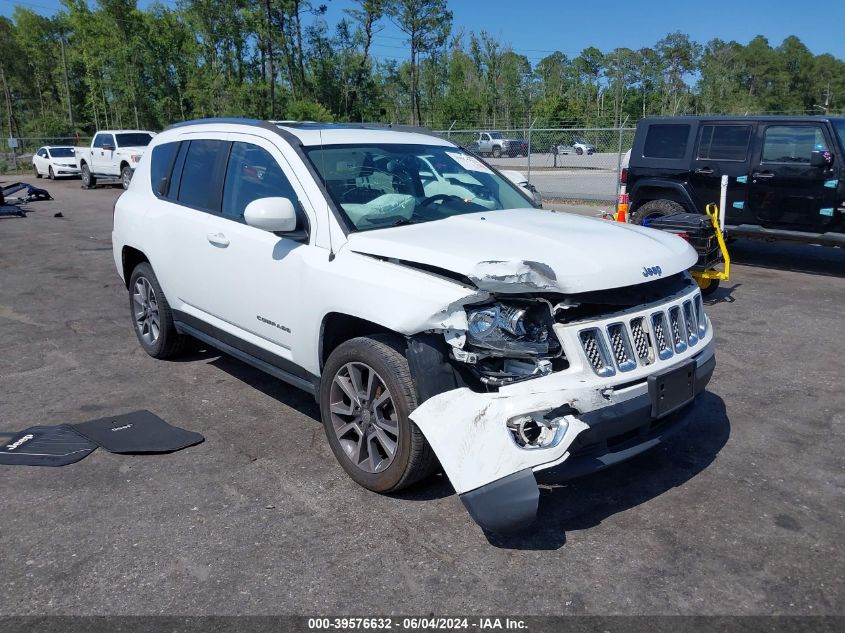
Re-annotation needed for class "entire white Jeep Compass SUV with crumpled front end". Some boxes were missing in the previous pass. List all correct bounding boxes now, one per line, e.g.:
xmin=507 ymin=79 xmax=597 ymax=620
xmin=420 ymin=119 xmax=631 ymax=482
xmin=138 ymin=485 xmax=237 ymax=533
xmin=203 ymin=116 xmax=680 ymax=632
xmin=113 ymin=119 xmax=715 ymax=531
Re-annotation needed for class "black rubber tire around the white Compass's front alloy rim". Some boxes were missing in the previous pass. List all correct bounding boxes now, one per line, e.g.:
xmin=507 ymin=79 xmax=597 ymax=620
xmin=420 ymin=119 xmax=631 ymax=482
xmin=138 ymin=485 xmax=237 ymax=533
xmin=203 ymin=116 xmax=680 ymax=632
xmin=320 ymin=334 xmax=437 ymax=493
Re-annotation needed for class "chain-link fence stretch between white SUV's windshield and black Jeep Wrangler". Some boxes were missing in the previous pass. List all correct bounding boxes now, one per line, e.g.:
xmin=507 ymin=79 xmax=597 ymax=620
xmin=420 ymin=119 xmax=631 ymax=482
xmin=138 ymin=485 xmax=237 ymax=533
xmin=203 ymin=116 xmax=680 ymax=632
xmin=436 ymin=127 xmax=634 ymax=201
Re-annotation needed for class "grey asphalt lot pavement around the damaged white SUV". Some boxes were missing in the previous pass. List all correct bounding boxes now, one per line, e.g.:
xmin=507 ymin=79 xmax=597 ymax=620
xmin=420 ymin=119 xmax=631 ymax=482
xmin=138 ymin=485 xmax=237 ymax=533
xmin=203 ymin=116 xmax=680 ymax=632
xmin=0 ymin=182 xmax=845 ymax=615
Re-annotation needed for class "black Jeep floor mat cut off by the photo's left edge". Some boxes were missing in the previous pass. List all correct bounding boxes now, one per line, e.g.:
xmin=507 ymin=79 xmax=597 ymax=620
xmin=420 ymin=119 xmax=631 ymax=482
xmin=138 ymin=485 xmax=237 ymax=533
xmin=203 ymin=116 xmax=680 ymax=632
xmin=0 ymin=424 xmax=97 ymax=466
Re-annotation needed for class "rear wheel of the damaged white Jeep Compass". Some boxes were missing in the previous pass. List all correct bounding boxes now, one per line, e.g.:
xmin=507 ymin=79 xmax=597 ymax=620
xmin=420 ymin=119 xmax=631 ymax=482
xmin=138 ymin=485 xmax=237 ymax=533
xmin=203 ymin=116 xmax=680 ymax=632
xmin=129 ymin=262 xmax=190 ymax=359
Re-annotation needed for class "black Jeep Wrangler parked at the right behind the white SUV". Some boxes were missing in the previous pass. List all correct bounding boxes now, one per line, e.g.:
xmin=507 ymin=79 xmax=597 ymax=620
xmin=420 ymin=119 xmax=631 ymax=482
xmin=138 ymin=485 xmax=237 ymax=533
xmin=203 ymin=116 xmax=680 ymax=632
xmin=623 ymin=116 xmax=845 ymax=246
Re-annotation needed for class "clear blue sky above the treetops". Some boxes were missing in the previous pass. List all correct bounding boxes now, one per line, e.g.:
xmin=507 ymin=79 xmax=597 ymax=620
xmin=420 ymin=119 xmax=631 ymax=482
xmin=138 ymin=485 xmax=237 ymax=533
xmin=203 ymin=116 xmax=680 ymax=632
xmin=0 ymin=0 xmax=845 ymax=63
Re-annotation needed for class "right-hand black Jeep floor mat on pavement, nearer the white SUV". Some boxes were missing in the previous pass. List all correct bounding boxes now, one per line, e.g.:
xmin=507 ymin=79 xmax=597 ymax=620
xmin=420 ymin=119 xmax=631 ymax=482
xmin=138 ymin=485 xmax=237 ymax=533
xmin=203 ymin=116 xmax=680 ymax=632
xmin=72 ymin=411 xmax=205 ymax=453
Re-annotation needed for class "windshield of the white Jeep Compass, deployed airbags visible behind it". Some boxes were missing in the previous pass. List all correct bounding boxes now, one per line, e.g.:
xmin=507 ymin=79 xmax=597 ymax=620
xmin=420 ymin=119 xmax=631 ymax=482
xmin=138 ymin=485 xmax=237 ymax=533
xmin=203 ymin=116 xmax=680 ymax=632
xmin=305 ymin=144 xmax=532 ymax=231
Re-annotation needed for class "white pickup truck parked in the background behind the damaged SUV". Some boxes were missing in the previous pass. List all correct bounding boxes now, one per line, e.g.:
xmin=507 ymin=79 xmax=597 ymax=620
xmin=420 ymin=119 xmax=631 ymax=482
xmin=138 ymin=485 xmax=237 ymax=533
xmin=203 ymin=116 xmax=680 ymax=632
xmin=75 ymin=130 xmax=155 ymax=189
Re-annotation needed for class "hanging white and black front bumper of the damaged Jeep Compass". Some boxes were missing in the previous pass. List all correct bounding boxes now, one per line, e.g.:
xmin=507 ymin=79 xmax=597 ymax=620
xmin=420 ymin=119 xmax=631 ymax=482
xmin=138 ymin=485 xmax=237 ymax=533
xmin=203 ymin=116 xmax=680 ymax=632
xmin=411 ymin=344 xmax=715 ymax=532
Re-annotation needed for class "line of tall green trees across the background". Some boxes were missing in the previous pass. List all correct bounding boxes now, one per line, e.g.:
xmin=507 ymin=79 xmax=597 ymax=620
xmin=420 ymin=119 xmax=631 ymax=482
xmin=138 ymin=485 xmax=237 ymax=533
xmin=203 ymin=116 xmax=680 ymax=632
xmin=0 ymin=0 xmax=845 ymax=137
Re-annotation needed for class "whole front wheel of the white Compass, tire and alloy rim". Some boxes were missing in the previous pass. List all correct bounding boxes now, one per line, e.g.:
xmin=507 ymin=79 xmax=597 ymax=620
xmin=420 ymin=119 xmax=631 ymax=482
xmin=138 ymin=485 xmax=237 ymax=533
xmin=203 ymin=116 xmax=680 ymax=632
xmin=320 ymin=335 xmax=437 ymax=492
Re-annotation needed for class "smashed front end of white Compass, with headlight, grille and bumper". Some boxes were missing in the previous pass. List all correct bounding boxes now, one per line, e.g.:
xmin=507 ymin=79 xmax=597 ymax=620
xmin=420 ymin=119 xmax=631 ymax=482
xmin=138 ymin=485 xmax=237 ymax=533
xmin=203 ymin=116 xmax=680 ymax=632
xmin=408 ymin=268 xmax=715 ymax=531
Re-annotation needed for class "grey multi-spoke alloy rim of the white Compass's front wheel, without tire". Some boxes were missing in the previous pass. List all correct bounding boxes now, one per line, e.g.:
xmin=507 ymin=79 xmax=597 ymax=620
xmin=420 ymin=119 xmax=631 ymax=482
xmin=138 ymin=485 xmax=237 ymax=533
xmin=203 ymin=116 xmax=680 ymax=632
xmin=329 ymin=362 xmax=400 ymax=473
